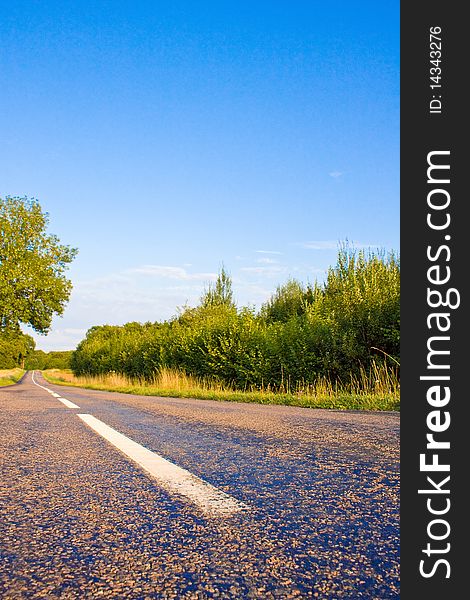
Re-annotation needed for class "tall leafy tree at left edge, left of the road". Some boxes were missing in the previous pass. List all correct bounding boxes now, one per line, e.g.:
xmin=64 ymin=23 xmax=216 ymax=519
xmin=0 ymin=196 xmax=77 ymax=334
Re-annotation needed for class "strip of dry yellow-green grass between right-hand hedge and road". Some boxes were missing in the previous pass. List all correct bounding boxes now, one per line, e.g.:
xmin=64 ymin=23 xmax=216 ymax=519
xmin=42 ymin=367 xmax=400 ymax=411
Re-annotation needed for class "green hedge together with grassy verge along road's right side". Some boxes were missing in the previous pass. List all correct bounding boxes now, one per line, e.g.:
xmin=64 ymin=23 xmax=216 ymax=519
xmin=56 ymin=247 xmax=400 ymax=410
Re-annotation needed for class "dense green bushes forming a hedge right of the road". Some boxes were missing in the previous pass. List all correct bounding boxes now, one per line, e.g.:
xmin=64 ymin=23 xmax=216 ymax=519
xmin=71 ymin=253 xmax=400 ymax=391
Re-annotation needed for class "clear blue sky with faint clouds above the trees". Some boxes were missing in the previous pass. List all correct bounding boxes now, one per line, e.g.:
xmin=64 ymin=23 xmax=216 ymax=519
xmin=0 ymin=0 xmax=399 ymax=350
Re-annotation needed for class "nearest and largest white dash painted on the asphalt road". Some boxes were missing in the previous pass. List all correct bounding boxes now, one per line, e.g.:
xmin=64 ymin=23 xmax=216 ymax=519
xmin=77 ymin=414 xmax=249 ymax=515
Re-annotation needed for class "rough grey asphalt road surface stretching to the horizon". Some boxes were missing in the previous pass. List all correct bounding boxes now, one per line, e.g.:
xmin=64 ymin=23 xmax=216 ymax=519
xmin=0 ymin=373 xmax=399 ymax=600
